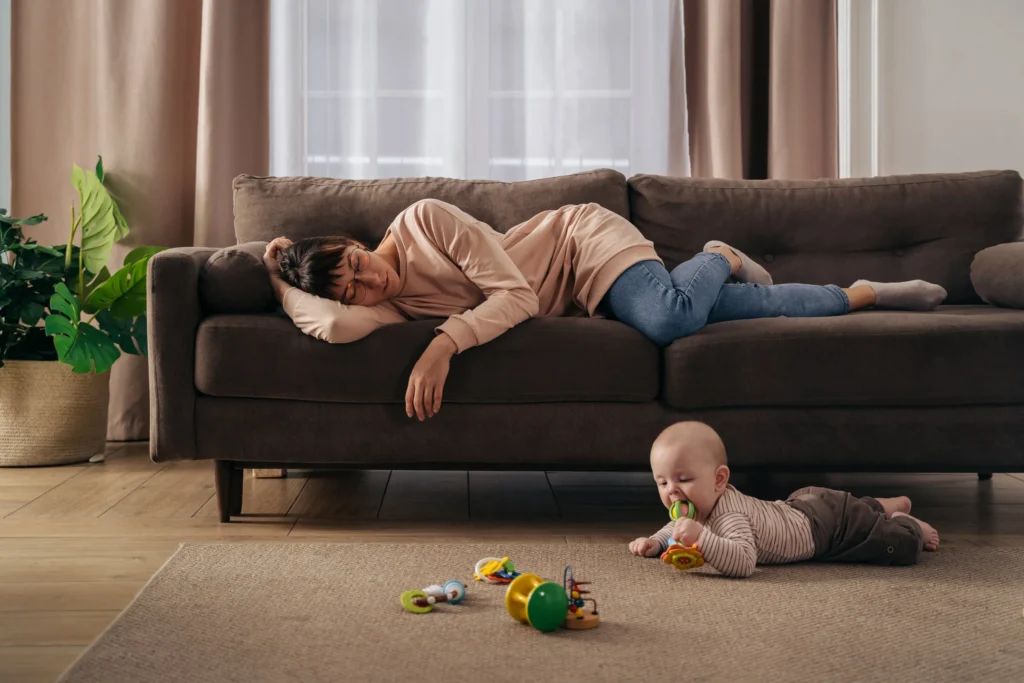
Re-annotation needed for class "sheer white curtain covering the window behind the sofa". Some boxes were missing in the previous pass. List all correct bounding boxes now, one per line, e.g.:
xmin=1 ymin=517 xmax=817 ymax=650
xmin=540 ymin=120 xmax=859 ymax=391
xmin=270 ymin=0 xmax=689 ymax=180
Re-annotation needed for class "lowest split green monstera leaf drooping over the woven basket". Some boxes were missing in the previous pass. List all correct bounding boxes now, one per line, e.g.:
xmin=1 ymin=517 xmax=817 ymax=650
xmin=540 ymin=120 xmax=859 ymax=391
xmin=45 ymin=283 xmax=121 ymax=373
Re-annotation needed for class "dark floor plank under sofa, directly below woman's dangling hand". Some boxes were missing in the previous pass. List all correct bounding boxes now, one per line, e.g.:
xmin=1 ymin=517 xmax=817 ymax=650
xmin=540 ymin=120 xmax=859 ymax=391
xmin=377 ymin=470 xmax=469 ymax=521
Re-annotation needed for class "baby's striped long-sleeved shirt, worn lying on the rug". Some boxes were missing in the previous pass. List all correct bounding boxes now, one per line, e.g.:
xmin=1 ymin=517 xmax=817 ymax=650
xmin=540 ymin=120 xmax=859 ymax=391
xmin=651 ymin=484 xmax=814 ymax=577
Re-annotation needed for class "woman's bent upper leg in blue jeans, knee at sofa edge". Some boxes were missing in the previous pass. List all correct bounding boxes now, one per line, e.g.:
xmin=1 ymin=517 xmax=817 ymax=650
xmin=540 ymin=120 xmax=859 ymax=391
xmin=602 ymin=252 xmax=738 ymax=346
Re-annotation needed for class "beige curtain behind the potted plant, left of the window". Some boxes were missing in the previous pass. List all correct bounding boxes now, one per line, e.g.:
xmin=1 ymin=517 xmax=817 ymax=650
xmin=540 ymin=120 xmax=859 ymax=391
xmin=11 ymin=0 xmax=269 ymax=440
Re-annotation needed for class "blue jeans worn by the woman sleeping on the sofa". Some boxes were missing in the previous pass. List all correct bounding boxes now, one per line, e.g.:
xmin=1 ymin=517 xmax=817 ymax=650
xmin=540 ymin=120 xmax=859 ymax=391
xmin=599 ymin=252 xmax=850 ymax=346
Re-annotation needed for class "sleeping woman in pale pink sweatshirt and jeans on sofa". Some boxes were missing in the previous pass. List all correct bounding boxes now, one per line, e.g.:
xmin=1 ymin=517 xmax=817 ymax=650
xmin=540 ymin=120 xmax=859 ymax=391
xmin=263 ymin=200 xmax=946 ymax=421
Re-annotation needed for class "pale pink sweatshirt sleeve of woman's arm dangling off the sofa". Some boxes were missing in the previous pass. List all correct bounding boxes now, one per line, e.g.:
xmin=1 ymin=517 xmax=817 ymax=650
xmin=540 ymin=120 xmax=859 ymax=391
xmin=411 ymin=200 xmax=540 ymax=353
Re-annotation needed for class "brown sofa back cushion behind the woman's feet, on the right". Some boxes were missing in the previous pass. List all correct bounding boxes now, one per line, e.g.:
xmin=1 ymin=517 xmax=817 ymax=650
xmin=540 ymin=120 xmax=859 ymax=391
xmin=629 ymin=171 xmax=1021 ymax=303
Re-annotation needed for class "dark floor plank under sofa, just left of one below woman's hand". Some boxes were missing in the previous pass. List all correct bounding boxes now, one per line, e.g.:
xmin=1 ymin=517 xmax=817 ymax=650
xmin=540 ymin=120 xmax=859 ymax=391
xmin=284 ymin=470 xmax=391 ymax=519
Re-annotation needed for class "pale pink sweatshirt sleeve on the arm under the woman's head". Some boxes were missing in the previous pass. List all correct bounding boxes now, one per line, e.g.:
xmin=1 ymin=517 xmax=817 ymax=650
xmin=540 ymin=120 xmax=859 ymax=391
xmin=281 ymin=287 xmax=406 ymax=344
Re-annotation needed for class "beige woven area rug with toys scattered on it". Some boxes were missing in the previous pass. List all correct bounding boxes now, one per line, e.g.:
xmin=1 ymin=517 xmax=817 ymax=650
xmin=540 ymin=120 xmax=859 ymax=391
xmin=61 ymin=544 xmax=1024 ymax=683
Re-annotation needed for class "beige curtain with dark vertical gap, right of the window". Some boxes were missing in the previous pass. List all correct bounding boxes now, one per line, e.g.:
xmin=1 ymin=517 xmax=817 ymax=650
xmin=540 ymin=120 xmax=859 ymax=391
xmin=683 ymin=0 xmax=839 ymax=178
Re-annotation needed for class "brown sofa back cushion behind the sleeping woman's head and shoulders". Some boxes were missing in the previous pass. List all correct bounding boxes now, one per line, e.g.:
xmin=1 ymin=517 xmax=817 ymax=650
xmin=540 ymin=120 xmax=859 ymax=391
xmin=234 ymin=169 xmax=629 ymax=245
